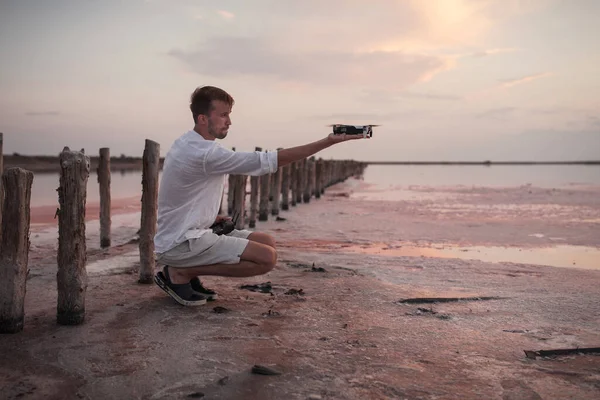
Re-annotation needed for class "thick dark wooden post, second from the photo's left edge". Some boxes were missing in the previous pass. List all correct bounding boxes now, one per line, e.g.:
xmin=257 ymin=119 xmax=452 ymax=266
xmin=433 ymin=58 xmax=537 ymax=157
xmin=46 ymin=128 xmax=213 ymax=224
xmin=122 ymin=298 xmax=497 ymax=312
xmin=56 ymin=147 xmax=90 ymax=325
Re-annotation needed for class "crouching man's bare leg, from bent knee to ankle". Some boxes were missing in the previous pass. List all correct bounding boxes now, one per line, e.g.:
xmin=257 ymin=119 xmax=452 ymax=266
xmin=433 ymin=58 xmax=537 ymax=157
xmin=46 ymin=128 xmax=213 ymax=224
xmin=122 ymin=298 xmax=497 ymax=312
xmin=169 ymin=238 xmax=277 ymax=284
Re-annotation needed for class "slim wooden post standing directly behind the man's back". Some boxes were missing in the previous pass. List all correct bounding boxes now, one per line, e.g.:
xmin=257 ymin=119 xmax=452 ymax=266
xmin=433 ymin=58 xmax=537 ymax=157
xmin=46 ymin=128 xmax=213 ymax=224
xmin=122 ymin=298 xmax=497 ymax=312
xmin=138 ymin=139 xmax=160 ymax=283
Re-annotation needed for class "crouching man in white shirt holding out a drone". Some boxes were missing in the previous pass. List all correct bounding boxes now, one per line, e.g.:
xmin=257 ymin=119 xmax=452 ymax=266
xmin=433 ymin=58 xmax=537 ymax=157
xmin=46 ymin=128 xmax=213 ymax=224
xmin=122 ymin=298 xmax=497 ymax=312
xmin=154 ymin=86 xmax=362 ymax=306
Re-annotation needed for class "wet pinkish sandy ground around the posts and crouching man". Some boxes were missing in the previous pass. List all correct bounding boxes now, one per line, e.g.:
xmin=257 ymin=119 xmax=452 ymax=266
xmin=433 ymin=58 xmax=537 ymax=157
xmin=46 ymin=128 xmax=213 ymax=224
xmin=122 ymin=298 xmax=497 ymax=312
xmin=0 ymin=179 xmax=600 ymax=400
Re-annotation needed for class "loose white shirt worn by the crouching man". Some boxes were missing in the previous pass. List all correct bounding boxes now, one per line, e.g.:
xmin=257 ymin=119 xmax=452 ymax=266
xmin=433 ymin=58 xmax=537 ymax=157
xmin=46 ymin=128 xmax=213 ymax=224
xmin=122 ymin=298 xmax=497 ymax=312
xmin=154 ymin=130 xmax=277 ymax=254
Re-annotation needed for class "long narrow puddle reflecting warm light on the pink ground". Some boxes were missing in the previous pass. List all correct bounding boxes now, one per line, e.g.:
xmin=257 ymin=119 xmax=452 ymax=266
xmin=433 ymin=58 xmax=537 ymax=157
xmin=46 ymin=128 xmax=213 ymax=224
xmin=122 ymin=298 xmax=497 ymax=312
xmin=340 ymin=243 xmax=600 ymax=270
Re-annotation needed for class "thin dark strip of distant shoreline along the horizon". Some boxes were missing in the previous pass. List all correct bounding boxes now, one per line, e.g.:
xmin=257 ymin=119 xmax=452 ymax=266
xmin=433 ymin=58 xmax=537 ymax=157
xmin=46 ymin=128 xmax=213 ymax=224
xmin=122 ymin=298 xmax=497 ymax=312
xmin=4 ymin=154 xmax=600 ymax=172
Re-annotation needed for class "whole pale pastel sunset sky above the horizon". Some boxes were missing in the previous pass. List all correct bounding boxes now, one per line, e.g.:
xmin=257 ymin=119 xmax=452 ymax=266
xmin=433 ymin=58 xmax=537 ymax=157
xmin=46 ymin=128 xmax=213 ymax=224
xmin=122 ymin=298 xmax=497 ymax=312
xmin=0 ymin=0 xmax=600 ymax=161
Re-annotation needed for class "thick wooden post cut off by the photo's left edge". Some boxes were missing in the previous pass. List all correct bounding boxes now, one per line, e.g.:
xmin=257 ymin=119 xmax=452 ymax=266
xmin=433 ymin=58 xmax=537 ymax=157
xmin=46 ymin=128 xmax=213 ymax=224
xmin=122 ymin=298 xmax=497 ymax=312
xmin=0 ymin=168 xmax=33 ymax=333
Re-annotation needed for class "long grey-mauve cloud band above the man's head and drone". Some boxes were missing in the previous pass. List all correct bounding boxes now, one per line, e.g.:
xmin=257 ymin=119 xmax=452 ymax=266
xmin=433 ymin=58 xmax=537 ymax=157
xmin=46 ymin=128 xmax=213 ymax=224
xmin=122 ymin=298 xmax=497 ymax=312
xmin=169 ymin=37 xmax=453 ymax=90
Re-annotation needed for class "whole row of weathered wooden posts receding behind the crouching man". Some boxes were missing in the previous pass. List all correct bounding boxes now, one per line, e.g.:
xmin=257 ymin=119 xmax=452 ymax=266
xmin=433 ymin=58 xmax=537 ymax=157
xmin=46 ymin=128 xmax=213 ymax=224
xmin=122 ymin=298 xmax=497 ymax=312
xmin=0 ymin=133 xmax=365 ymax=333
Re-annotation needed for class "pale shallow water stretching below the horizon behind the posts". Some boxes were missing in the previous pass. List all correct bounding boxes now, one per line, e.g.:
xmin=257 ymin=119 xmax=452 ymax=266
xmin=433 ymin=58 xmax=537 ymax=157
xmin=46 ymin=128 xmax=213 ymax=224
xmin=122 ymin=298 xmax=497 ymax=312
xmin=31 ymin=165 xmax=600 ymax=207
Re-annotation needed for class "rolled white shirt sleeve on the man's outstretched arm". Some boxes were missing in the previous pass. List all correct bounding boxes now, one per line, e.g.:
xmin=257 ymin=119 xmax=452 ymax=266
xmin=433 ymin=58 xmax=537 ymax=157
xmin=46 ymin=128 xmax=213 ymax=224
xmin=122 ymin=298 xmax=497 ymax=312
xmin=204 ymin=143 xmax=278 ymax=176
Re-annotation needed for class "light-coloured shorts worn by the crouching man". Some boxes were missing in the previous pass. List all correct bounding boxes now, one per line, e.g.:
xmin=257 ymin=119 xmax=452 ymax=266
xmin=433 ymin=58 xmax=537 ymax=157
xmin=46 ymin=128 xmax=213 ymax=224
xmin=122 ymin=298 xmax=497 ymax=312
xmin=156 ymin=229 xmax=252 ymax=267
